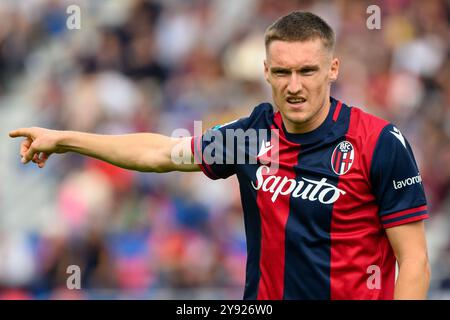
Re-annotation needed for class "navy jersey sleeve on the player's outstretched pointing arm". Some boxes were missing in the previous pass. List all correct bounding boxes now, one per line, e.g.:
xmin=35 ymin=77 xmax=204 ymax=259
xmin=191 ymin=104 xmax=271 ymax=180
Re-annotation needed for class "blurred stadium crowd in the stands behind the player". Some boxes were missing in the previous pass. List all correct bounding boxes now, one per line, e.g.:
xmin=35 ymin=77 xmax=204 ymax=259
xmin=0 ymin=0 xmax=450 ymax=299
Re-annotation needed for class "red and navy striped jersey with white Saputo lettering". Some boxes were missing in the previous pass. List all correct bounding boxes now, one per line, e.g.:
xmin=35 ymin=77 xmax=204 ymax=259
xmin=191 ymin=97 xmax=428 ymax=299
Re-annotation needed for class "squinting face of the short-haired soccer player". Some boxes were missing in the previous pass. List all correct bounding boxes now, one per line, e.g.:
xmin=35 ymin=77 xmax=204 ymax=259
xmin=264 ymin=39 xmax=339 ymax=133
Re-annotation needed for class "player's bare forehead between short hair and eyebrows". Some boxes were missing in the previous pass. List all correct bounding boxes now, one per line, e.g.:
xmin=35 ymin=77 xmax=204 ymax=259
xmin=267 ymin=39 xmax=328 ymax=68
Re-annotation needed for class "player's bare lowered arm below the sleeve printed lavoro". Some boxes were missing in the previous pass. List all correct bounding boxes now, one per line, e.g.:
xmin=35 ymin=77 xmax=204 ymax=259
xmin=386 ymin=221 xmax=430 ymax=300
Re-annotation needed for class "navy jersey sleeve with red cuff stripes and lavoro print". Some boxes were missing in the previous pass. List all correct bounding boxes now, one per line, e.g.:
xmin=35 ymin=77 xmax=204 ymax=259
xmin=370 ymin=124 xmax=428 ymax=228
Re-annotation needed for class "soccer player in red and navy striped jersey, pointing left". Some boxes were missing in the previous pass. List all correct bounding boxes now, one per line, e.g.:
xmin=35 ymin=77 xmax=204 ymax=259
xmin=10 ymin=11 xmax=430 ymax=299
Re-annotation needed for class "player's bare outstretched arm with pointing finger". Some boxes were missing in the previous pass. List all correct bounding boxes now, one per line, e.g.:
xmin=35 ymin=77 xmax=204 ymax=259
xmin=9 ymin=127 xmax=200 ymax=172
